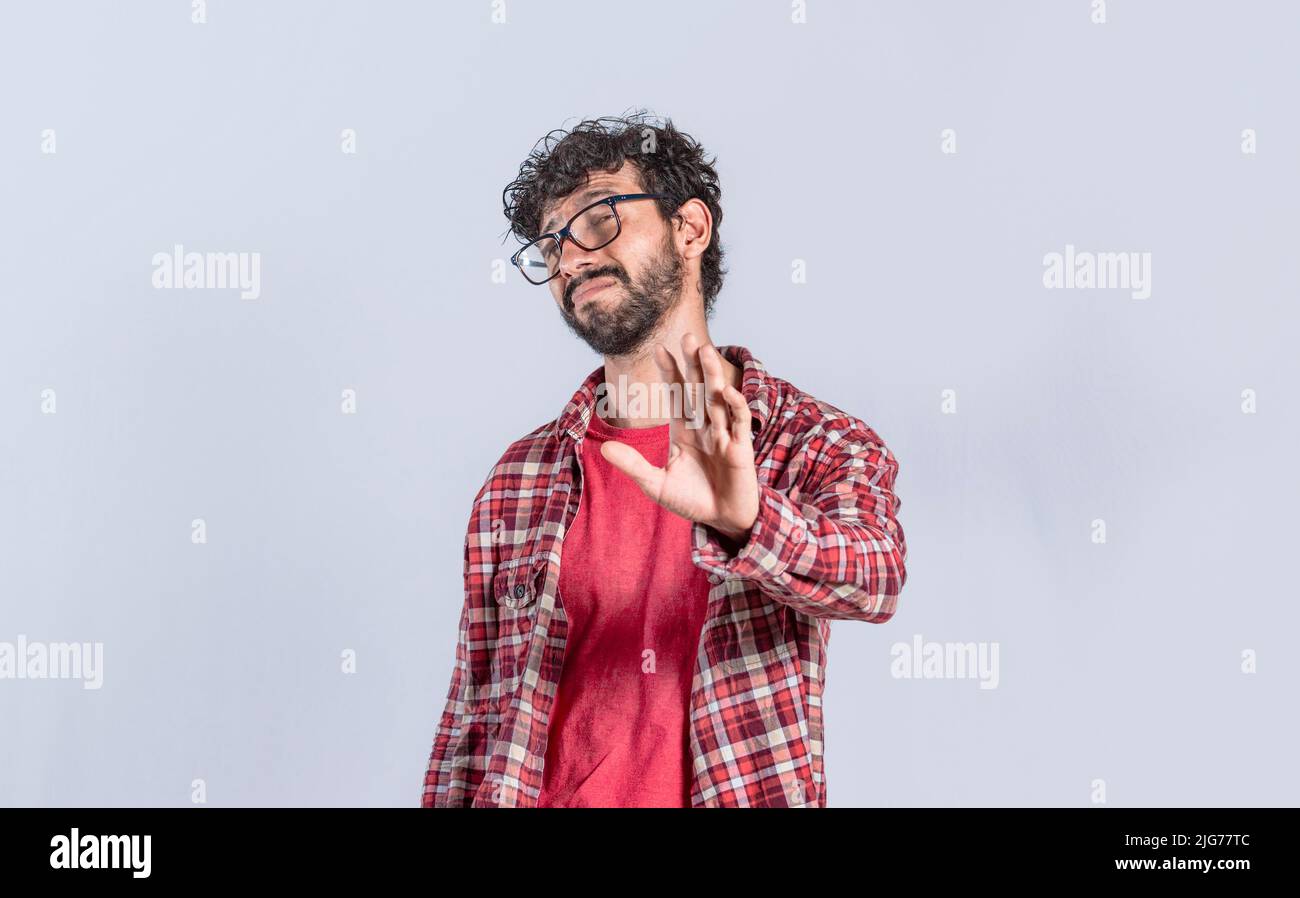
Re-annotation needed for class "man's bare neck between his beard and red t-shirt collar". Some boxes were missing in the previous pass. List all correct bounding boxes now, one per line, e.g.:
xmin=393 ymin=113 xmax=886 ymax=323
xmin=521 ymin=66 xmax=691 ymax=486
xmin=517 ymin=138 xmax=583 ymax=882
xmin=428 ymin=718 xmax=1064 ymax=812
xmin=603 ymin=293 xmax=742 ymax=428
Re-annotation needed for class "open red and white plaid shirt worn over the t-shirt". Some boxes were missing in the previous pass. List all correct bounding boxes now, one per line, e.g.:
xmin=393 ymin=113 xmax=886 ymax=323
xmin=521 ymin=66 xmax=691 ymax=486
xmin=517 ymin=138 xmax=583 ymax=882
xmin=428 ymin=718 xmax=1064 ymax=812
xmin=421 ymin=346 xmax=907 ymax=807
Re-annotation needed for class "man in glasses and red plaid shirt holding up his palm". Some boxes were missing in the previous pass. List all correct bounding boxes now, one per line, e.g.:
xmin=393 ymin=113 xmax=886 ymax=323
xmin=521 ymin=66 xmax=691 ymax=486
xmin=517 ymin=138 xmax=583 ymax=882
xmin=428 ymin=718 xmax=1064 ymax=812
xmin=423 ymin=116 xmax=906 ymax=807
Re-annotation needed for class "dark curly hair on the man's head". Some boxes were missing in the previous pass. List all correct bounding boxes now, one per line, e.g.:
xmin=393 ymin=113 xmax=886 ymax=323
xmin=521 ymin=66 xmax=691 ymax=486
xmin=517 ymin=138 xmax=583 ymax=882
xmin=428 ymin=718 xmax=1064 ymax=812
xmin=502 ymin=110 xmax=727 ymax=316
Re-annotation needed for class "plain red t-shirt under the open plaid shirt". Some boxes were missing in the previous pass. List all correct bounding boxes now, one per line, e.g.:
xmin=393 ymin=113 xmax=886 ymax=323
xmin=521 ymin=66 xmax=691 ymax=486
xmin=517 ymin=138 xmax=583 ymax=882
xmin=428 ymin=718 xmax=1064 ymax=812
xmin=538 ymin=413 xmax=709 ymax=807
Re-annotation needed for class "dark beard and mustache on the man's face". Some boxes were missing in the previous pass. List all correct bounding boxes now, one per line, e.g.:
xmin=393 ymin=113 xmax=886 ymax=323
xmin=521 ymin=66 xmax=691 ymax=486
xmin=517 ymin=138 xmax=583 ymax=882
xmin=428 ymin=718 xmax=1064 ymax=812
xmin=560 ymin=239 xmax=685 ymax=356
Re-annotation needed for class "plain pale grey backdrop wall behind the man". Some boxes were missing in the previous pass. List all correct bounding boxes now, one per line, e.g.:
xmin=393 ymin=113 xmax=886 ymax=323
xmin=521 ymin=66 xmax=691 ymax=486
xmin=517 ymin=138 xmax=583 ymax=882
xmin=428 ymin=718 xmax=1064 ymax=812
xmin=0 ymin=0 xmax=1300 ymax=807
